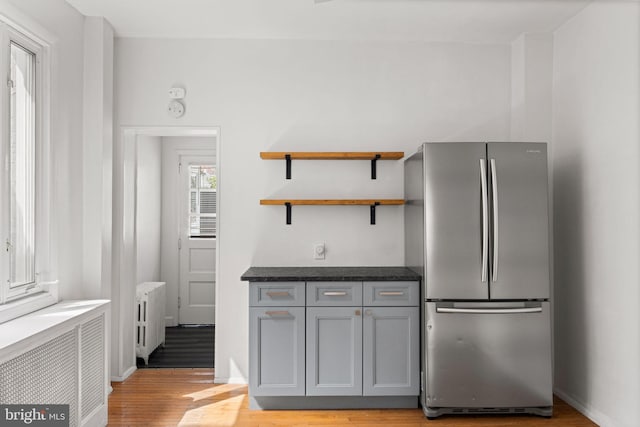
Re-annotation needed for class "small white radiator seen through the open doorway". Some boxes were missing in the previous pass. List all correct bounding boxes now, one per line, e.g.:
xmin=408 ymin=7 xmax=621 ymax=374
xmin=136 ymin=282 xmax=166 ymax=365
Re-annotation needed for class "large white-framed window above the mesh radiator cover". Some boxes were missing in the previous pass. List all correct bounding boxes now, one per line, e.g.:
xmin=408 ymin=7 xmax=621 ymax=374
xmin=0 ymin=23 xmax=57 ymax=323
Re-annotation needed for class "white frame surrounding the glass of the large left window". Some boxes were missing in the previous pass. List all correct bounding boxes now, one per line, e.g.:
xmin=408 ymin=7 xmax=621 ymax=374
xmin=0 ymin=17 xmax=59 ymax=323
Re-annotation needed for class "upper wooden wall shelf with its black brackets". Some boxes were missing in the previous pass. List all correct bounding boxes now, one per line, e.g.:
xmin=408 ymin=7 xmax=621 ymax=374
xmin=260 ymin=151 xmax=404 ymax=179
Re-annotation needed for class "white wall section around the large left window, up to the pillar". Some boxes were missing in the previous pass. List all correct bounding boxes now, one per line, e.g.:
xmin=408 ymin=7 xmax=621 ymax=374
xmin=0 ymin=0 xmax=87 ymax=298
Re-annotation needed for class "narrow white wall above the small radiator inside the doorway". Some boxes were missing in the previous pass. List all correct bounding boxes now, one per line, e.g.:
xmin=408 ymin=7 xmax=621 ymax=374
xmin=136 ymin=135 xmax=162 ymax=283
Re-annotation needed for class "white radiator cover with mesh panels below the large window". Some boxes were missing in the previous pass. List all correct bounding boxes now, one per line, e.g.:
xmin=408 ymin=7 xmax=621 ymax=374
xmin=0 ymin=300 xmax=109 ymax=426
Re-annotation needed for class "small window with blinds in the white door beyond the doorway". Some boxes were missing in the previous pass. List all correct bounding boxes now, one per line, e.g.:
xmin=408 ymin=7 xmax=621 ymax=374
xmin=189 ymin=165 xmax=218 ymax=238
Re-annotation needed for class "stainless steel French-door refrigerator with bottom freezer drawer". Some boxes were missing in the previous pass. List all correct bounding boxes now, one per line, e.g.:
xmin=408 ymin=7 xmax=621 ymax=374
xmin=405 ymin=142 xmax=552 ymax=418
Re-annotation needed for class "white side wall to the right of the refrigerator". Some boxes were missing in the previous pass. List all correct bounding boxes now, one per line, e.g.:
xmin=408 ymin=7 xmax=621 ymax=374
xmin=552 ymin=1 xmax=640 ymax=427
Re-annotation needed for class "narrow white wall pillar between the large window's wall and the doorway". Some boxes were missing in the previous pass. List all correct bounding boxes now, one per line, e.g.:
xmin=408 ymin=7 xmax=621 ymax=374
xmin=82 ymin=17 xmax=117 ymax=300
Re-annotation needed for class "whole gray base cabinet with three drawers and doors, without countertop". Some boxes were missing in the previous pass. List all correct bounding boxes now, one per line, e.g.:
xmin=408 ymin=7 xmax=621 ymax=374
xmin=249 ymin=281 xmax=420 ymax=409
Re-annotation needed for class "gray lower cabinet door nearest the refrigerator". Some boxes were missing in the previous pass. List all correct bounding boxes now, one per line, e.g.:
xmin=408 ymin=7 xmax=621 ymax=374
xmin=363 ymin=307 xmax=420 ymax=396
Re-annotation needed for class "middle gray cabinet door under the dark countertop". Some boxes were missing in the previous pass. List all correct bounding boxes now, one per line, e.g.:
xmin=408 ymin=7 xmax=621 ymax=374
xmin=307 ymin=307 xmax=362 ymax=396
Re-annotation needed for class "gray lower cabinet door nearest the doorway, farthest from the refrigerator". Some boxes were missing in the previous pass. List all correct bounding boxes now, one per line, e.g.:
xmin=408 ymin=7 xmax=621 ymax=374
xmin=249 ymin=307 xmax=305 ymax=396
